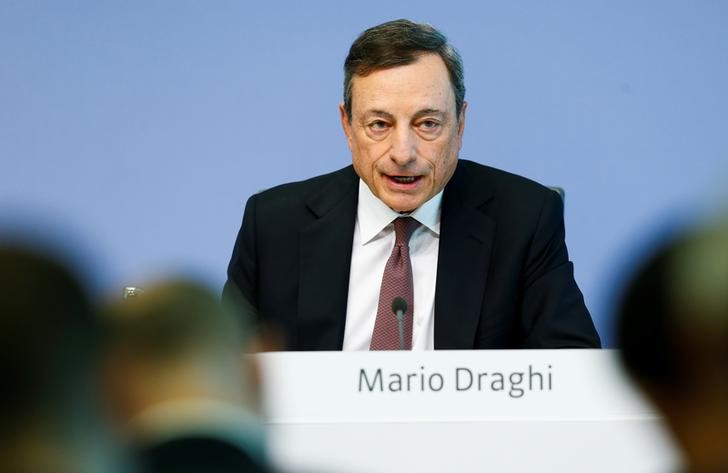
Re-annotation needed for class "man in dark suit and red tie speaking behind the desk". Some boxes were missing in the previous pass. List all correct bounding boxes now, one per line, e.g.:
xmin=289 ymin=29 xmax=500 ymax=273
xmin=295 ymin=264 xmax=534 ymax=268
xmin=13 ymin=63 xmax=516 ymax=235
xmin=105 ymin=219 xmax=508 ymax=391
xmin=224 ymin=20 xmax=599 ymax=350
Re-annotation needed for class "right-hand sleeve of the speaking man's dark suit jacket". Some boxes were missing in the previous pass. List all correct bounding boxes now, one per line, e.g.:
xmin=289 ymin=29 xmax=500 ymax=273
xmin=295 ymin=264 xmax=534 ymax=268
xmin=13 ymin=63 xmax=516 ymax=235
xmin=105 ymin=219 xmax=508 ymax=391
xmin=522 ymin=191 xmax=601 ymax=348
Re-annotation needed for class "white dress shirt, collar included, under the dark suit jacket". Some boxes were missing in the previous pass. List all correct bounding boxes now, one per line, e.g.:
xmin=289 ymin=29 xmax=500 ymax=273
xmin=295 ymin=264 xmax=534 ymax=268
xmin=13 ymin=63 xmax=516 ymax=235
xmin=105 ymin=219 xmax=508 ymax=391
xmin=343 ymin=179 xmax=442 ymax=351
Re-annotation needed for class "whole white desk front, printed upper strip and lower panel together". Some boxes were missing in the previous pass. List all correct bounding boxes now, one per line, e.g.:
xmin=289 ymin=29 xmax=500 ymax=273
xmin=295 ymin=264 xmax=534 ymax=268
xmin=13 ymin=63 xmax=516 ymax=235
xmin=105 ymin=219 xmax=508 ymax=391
xmin=257 ymin=350 xmax=680 ymax=473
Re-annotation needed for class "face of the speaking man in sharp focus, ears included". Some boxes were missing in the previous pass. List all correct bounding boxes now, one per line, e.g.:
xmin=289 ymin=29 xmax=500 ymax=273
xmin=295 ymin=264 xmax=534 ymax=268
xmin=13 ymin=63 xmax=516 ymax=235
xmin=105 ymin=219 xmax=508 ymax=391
xmin=339 ymin=54 xmax=467 ymax=212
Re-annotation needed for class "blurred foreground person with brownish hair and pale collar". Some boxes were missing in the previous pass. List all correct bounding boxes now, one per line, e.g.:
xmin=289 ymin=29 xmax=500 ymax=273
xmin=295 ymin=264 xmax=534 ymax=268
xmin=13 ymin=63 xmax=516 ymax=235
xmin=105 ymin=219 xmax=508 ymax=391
xmin=104 ymin=280 xmax=280 ymax=473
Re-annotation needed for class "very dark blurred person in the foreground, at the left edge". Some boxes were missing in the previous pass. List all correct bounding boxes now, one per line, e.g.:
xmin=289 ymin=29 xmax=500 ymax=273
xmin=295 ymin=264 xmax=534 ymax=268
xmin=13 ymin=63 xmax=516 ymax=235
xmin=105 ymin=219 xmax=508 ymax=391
xmin=0 ymin=243 xmax=128 ymax=473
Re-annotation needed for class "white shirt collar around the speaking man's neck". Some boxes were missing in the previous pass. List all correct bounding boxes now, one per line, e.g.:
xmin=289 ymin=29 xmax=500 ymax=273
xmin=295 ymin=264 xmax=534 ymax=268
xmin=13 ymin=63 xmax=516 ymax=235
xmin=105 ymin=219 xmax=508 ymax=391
xmin=357 ymin=179 xmax=442 ymax=245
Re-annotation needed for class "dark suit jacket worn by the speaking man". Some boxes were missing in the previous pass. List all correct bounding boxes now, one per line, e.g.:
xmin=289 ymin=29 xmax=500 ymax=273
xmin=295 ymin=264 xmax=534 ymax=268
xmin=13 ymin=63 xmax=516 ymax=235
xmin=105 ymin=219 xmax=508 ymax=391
xmin=224 ymin=160 xmax=600 ymax=350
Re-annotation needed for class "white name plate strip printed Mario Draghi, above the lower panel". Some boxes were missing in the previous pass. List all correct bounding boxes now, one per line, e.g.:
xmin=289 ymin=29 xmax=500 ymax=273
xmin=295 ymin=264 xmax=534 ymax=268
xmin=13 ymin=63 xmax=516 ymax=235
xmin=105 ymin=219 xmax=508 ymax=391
xmin=256 ymin=350 xmax=657 ymax=423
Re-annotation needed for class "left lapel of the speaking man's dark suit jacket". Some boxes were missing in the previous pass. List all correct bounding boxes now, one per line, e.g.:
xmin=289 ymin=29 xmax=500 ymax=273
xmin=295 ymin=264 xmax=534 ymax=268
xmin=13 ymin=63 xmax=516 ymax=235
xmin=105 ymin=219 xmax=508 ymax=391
xmin=298 ymin=166 xmax=358 ymax=350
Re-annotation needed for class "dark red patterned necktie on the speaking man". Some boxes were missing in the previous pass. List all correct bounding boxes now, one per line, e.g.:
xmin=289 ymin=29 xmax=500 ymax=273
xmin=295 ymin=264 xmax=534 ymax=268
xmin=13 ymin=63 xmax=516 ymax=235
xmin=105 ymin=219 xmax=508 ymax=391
xmin=369 ymin=217 xmax=418 ymax=350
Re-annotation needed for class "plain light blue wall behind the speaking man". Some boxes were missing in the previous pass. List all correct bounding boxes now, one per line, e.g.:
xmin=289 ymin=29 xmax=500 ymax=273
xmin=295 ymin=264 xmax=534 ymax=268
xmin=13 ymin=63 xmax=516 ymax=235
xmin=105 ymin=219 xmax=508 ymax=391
xmin=0 ymin=0 xmax=728 ymax=345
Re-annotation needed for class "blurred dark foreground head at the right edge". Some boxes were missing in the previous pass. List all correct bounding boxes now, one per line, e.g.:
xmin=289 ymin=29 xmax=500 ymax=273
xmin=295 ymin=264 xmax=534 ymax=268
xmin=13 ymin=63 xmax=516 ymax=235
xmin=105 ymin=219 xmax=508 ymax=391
xmin=618 ymin=220 xmax=728 ymax=472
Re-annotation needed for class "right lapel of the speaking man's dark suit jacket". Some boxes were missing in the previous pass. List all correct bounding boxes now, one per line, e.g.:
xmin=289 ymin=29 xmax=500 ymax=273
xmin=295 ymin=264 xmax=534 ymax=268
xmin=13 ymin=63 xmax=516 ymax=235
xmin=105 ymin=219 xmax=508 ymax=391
xmin=435 ymin=161 xmax=495 ymax=350
